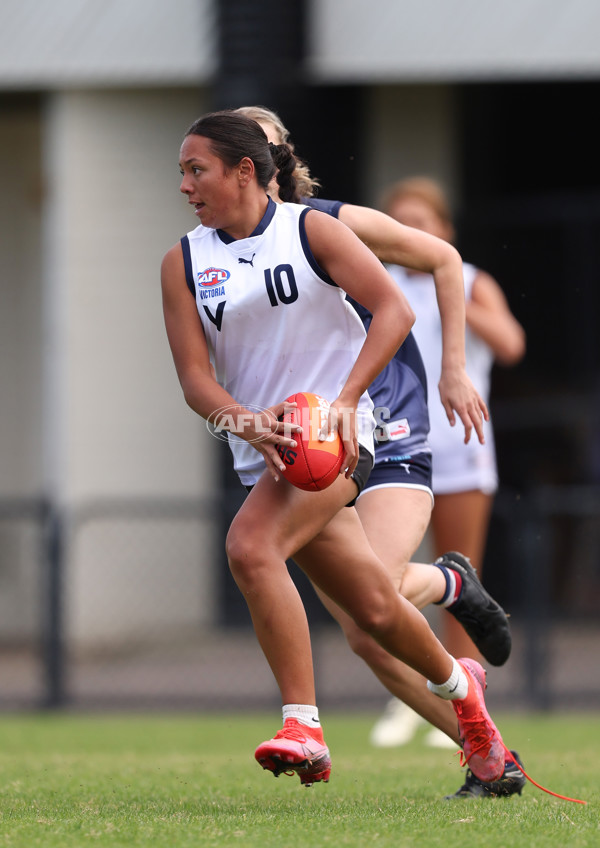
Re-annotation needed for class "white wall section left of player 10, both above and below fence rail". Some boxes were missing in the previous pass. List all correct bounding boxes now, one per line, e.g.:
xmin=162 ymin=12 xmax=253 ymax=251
xmin=43 ymin=91 xmax=216 ymax=646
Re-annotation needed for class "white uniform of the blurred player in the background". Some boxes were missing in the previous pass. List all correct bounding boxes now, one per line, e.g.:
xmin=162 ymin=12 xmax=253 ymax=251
xmin=388 ymin=263 xmax=498 ymax=494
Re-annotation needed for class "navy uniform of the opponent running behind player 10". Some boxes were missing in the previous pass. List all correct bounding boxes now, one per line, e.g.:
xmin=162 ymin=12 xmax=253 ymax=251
xmin=304 ymin=197 xmax=433 ymax=497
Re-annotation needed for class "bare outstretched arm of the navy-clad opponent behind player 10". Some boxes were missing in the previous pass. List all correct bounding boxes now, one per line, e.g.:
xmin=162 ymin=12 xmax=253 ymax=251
xmin=339 ymin=204 xmax=489 ymax=442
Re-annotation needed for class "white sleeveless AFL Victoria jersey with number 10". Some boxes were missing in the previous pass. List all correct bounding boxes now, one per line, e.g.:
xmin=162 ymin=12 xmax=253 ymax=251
xmin=182 ymin=200 xmax=375 ymax=485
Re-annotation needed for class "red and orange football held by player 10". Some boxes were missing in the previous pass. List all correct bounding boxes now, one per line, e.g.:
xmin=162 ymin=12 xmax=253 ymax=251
xmin=279 ymin=392 xmax=344 ymax=492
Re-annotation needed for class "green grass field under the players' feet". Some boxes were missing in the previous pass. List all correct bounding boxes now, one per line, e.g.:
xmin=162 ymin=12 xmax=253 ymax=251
xmin=0 ymin=710 xmax=600 ymax=848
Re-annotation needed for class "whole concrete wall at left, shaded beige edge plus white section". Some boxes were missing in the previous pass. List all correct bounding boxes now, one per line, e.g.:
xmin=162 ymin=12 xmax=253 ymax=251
xmin=0 ymin=90 xmax=223 ymax=645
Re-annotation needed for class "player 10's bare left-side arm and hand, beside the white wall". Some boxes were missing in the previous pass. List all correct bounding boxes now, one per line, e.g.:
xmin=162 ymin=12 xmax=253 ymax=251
xmin=161 ymin=244 xmax=299 ymax=480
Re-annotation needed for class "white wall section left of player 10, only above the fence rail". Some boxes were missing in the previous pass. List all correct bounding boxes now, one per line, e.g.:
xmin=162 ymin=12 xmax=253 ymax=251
xmin=44 ymin=91 xmax=211 ymax=504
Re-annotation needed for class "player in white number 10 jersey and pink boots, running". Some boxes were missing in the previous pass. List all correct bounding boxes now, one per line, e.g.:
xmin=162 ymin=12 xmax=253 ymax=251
xmin=162 ymin=112 xmax=505 ymax=785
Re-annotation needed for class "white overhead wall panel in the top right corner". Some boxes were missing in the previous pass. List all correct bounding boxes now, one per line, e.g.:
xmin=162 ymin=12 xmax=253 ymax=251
xmin=308 ymin=0 xmax=600 ymax=84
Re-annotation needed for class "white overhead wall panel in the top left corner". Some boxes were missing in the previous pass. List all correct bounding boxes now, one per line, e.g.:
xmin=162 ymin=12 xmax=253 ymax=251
xmin=0 ymin=0 xmax=215 ymax=90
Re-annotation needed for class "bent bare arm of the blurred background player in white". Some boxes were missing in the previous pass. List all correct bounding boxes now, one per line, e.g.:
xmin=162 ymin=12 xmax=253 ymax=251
xmin=466 ymin=271 xmax=526 ymax=365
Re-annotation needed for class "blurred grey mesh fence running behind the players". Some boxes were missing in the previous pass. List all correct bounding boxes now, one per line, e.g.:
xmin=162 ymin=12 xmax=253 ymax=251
xmin=0 ymin=486 xmax=600 ymax=710
